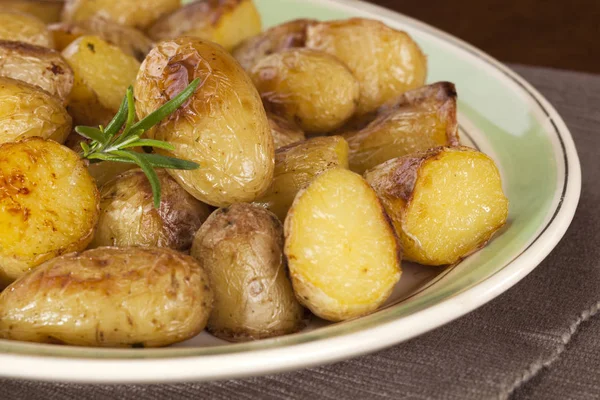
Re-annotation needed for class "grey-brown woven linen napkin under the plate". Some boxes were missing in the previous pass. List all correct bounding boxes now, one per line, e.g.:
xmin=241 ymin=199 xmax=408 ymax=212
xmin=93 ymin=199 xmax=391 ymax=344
xmin=0 ymin=66 xmax=600 ymax=400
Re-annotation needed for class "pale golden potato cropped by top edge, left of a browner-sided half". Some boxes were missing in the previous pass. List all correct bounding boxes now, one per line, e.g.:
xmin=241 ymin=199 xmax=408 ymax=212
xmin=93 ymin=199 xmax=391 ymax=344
xmin=62 ymin=0 xmax=181 ymax=30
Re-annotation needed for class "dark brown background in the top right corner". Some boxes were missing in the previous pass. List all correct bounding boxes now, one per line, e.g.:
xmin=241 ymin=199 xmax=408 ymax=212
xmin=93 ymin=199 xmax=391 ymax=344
xmin=370 ymin=0 xmax=600 ymax=73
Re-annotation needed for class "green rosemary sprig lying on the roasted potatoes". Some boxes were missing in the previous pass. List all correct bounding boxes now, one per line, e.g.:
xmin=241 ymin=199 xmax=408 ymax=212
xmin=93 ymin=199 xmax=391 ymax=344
xmin=75 ymin=79 xmax=200 ymax=208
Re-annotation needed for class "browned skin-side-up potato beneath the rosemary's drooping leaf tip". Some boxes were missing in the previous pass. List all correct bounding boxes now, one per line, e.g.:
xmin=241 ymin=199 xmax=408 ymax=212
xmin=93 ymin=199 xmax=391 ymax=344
xmin=89 ymin=169 xmax=212 ymax=251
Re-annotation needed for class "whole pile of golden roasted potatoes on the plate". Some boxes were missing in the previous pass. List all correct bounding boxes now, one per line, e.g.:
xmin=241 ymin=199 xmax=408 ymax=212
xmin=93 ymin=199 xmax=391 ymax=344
xmin=0 ymin=0 xmax=508 ymax=347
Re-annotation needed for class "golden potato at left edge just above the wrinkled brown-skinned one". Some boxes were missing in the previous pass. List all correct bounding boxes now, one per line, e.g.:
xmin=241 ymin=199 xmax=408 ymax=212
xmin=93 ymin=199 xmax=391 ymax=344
xmin=0 ymin=9 xmax=54 ymax=48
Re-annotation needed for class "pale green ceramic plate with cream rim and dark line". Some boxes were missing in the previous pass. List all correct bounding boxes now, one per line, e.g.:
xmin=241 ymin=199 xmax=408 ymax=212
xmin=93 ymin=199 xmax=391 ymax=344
xmin=0 ymin=0 xmax=581 ymax=382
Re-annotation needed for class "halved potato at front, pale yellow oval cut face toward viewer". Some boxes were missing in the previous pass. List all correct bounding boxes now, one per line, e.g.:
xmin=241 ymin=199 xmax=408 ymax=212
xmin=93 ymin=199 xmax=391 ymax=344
xmin=285 ymin=168 xmax=401 ymax=321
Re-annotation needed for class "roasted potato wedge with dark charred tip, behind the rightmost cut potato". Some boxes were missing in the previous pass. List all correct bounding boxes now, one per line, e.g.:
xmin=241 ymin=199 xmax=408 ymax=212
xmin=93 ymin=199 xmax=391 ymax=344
xmin=343 ymin=82 xmax=459 ymax=174
